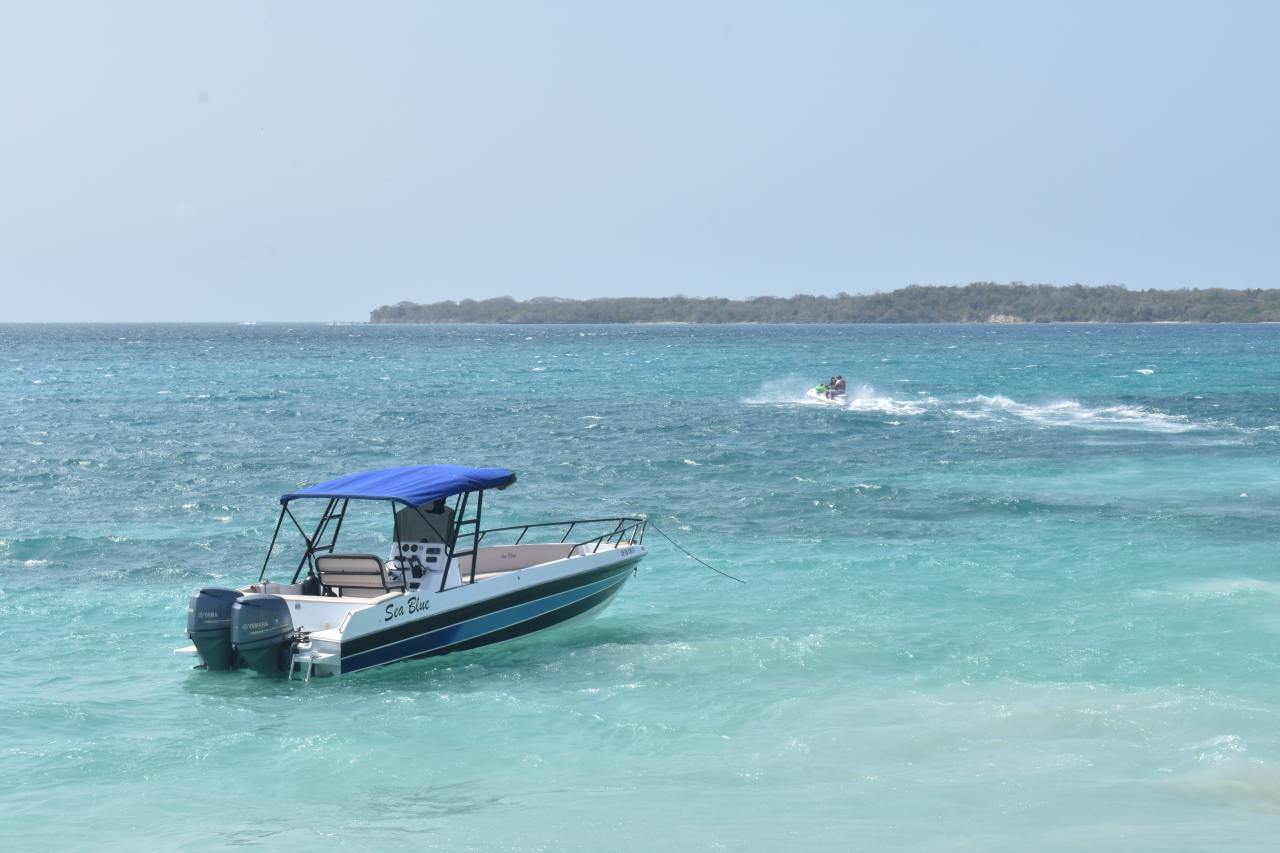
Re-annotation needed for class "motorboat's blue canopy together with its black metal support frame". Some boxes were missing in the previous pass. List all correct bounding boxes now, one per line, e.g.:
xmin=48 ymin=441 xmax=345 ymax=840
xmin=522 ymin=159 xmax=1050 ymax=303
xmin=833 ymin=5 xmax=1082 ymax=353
xmin=259 ymin=465 xmax=516 ymax=592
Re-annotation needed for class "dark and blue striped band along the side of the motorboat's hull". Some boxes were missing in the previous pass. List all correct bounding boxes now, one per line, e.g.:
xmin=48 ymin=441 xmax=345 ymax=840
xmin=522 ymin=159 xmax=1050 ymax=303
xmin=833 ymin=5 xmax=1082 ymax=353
xmin=342 ymin=570 xmax=631 ymax=674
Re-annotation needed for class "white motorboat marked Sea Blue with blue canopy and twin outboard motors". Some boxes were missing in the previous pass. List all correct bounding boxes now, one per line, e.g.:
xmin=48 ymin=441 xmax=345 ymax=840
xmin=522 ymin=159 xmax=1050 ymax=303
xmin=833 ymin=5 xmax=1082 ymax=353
xmin=175 ymin=465 xmax=646 ymax=680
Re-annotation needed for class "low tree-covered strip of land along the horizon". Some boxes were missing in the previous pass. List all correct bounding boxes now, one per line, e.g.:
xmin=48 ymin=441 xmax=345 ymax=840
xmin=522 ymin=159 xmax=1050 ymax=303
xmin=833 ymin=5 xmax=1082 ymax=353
xmin=369 ymin=282 xmax=1280 ymax=323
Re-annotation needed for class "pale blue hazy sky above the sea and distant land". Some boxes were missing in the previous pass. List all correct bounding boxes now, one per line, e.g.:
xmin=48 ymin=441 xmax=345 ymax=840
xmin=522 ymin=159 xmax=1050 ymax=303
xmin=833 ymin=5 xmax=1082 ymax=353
xmin=0 ymin=0 xmax=1280 ymax=320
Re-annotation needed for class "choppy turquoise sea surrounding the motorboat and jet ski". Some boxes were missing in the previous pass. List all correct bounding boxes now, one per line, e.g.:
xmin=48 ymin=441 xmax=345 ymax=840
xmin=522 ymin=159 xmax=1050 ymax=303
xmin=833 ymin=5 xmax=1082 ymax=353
xmin=0 ymin=325 xmax=1280 ymax=852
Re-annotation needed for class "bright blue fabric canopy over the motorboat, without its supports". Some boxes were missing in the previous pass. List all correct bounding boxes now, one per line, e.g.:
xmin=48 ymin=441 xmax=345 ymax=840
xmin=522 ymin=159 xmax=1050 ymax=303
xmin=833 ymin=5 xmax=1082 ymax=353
xmin=280 ymin=465 xmax=516 ymax=506
